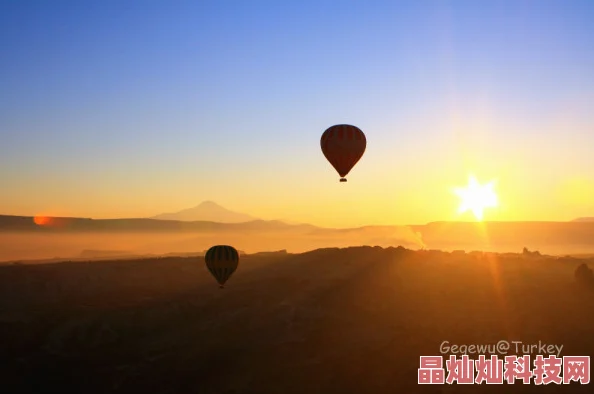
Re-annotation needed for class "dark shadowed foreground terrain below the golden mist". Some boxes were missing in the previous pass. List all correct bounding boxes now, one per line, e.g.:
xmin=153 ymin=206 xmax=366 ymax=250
xmin=0 ymin=247 xmax=594 ymax=394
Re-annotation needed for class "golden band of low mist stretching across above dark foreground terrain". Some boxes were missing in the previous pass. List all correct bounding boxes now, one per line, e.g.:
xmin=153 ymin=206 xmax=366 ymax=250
xmin=0 ymin=222 xmax=594 ymax=262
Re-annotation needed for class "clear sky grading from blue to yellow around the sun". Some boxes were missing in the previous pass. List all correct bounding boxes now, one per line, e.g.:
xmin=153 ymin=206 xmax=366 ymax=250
xmin=0 ymin=0 xmax=594 ymax=227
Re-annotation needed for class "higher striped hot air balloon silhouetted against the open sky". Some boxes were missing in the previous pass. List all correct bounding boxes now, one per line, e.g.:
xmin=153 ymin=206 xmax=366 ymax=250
xmin=320 ymin=124 xmax=367 ymax=182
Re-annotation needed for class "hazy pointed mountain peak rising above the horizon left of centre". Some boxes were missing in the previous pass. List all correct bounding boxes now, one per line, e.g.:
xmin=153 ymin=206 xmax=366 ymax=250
xmin=150 ymin=201 xmax=258 ymax=223
